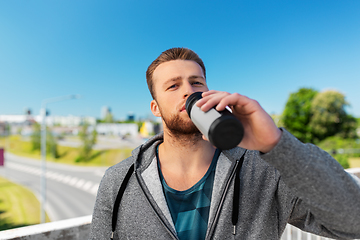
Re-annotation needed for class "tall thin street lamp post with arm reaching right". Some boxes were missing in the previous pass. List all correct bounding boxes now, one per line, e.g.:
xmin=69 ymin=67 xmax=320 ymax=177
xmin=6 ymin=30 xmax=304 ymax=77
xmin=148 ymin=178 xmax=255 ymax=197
xmin=40 ymin=95 xmax=80 ymax=223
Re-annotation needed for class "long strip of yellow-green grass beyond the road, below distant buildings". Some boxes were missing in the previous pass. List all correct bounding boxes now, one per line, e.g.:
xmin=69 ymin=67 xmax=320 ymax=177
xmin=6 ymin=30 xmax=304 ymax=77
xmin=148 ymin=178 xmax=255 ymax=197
xmin=0 ymin=135 xmax=132 ymax=166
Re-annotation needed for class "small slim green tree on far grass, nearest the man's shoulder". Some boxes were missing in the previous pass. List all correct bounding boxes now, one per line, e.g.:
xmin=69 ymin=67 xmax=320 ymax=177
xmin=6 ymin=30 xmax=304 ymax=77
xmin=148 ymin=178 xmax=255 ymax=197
xmin=76 ymin=123 xmax=97 ymax=162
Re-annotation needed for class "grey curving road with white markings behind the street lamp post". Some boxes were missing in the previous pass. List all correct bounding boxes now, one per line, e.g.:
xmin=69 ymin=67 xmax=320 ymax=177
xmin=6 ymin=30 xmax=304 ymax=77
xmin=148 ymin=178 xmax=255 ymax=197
xmin=0 ymin=153 xmax=107 ymax=221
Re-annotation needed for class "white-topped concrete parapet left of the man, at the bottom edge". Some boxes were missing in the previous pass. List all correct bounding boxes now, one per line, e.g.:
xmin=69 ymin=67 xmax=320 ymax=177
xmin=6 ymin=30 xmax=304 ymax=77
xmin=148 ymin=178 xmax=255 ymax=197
xmin=0 ymin=215 xmax=91 ymax=240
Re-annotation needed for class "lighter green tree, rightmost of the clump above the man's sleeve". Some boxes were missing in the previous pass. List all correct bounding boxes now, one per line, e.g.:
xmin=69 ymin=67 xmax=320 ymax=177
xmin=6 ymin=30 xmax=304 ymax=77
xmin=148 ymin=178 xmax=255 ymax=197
xmin=309 ymin=90 xmax=356 ymax=142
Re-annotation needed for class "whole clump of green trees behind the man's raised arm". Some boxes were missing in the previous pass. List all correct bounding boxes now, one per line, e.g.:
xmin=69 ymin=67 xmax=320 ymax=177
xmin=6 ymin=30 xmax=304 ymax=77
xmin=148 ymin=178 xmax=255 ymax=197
xmin=281 ymin=88 xmax=356 ymax=143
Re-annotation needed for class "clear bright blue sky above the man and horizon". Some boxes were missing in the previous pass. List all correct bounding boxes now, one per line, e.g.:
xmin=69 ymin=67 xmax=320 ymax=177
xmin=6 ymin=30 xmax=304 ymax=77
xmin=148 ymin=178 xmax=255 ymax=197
xmin=0 ymin=0 xmax=360 ymax=119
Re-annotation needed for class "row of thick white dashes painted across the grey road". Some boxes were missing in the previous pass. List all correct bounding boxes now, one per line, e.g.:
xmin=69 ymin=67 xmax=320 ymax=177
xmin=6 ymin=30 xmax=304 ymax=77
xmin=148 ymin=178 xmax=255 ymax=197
xmin=6 ymin=162 xmax=99 ymax=196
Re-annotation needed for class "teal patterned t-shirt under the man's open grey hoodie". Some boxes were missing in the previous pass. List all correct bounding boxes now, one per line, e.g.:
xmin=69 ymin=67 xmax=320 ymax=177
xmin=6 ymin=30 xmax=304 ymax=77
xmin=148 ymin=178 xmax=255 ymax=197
xmin=157 ymin=149 xmax=220 ymax=240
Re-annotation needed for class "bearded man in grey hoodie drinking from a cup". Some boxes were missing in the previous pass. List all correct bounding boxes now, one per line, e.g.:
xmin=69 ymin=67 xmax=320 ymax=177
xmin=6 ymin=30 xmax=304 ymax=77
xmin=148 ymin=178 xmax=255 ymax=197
xmin=90 ymin=48 xmax=360 ymax=239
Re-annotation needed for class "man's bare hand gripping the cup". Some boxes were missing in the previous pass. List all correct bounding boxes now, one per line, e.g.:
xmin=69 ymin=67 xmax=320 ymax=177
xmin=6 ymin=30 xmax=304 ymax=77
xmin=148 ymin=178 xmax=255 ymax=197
xmin=196 ymin=90 xmax=281 ymax=153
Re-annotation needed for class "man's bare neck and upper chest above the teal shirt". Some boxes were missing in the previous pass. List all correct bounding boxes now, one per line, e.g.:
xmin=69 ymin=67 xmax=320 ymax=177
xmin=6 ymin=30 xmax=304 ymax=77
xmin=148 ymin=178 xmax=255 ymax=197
xmin=159 ymin=127 xmax=215 ymax=191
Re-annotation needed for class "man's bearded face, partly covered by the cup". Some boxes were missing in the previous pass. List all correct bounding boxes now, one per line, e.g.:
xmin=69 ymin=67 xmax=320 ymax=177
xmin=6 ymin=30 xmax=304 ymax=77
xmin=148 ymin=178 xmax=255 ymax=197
xmin=151 ymin=60 xmax=209 ymax=134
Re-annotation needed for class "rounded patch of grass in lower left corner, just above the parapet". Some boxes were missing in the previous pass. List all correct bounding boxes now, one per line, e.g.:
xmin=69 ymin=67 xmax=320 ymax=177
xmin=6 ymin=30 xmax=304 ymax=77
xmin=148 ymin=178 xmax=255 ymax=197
xmin=0 ymin=178 xmax=49 ymax=231
